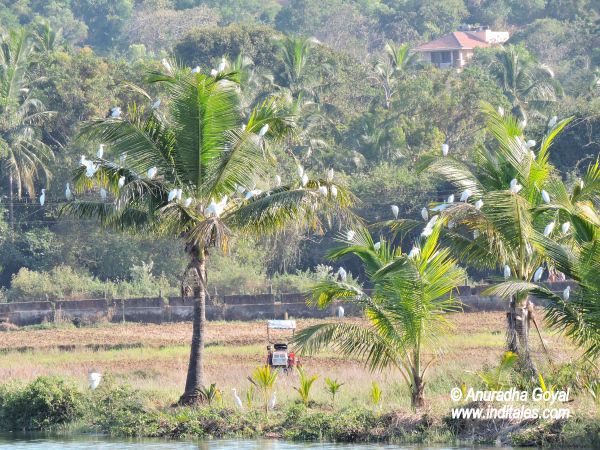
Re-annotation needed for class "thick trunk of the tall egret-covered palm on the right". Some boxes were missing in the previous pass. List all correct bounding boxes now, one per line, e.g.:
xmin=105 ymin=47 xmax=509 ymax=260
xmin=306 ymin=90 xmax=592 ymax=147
xmin=506 ymin=297 xmax=536 ymax=374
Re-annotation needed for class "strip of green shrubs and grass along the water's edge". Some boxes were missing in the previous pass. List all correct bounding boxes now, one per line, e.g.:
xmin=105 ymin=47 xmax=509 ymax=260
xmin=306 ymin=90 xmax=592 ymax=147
xmin=0 ymin=377 xmax=600 ymax=448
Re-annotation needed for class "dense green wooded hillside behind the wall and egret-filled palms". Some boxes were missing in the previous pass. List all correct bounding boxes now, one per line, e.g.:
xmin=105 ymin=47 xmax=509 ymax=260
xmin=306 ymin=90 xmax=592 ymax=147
xmin=0 ymin=0 xmax=600 ymax=299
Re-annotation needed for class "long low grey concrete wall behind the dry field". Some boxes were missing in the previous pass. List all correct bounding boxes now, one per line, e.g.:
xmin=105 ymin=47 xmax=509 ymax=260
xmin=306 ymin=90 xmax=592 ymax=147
xmin=0 ymin=283 xmax=569 ymax=326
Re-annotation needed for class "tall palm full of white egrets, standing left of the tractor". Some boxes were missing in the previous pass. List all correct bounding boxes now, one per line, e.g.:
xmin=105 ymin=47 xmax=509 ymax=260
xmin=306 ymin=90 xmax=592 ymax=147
xmin=64 ymin=64 xmax=352 ymax=404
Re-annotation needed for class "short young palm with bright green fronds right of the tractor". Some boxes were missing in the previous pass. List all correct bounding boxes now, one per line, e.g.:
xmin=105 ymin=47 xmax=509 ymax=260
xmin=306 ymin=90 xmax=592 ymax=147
xmin=295 ymin=222 xmax=465 ymax=407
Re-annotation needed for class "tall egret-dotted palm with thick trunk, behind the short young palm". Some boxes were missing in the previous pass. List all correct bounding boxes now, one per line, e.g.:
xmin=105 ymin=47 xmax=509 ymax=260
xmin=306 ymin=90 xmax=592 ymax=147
xmin=414 ymin=104 xmax=570 ymax=372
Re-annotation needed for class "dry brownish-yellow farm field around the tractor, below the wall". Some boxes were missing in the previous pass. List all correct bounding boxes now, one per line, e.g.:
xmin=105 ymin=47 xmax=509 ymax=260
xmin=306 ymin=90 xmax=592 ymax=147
xmin=0 ymin=312 xmax=575 ymax=412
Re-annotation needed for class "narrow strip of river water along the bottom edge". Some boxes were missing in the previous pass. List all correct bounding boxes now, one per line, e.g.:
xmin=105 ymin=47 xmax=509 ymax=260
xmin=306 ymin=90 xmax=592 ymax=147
xmin=0 ymin=435 xmax=506 ymax=450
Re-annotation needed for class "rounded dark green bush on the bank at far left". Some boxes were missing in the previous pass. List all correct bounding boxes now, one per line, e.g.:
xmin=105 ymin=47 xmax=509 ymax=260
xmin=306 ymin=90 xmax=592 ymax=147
xmin=0 ymin=377 xmax=83 ymax=431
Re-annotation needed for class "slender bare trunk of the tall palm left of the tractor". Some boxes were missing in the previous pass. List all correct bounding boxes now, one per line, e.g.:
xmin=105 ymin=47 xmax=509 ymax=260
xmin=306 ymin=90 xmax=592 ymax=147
xmin=178 ymin=246 xmax=208 ymax=405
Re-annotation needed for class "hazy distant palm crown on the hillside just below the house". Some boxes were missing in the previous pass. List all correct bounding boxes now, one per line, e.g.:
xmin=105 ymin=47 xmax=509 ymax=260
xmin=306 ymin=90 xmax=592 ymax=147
xmin=495 ymin=45 xmax=562 ymax=123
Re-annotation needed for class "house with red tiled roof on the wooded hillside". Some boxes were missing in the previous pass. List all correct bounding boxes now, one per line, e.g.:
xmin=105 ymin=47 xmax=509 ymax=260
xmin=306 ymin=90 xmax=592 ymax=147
xmin=414 ymin=27 xmax=509 ymax=69
